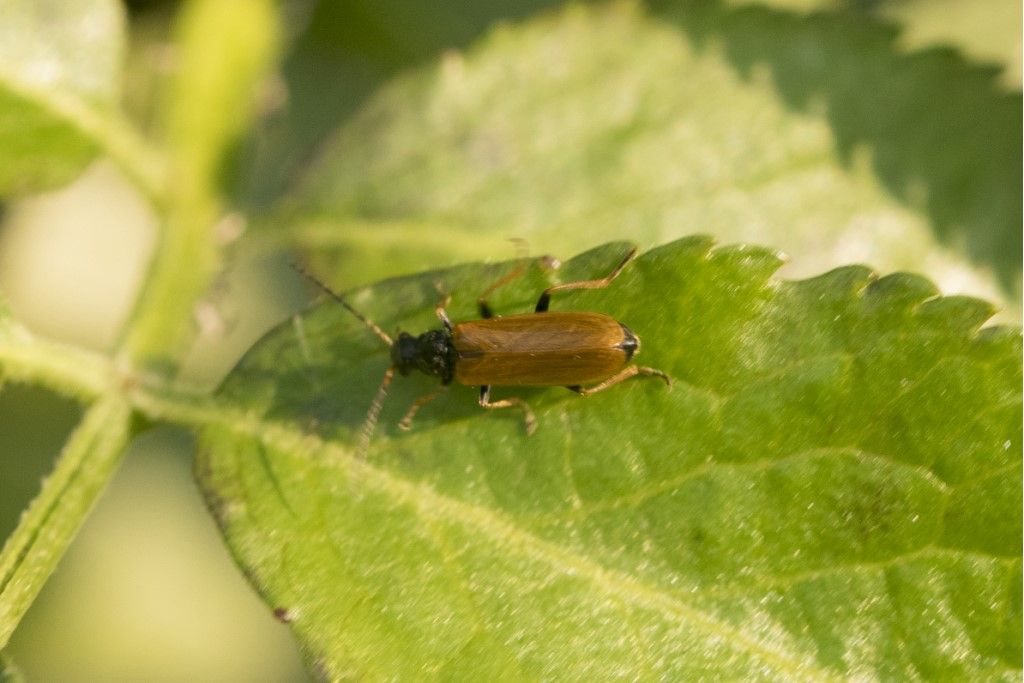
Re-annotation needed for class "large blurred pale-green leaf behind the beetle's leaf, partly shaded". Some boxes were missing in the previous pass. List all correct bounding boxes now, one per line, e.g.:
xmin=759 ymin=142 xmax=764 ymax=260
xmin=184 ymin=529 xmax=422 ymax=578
xmin=284 ymin=2 xmax=1021 ymax=296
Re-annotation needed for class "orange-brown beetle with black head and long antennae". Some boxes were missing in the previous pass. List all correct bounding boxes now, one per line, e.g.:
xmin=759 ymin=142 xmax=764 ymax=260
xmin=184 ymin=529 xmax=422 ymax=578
xmin=296 ymin=248 xmax=672 ymax=454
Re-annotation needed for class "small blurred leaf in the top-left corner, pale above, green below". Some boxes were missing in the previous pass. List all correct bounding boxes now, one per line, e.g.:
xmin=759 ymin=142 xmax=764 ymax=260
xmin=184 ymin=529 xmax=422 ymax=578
xmin=0 ymin=0 xmax=158 ymax=196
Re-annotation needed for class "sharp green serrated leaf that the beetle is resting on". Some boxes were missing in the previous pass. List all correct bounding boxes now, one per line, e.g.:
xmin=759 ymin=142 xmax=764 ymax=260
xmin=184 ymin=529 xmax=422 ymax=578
xmin=197 ymin=238 xmax=1021 ymax=680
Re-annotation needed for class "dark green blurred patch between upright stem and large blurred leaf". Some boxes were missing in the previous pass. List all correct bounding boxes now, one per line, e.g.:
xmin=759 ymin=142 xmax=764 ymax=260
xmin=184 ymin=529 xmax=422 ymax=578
xmin=239 ymin=0 xmax=560 ymax=207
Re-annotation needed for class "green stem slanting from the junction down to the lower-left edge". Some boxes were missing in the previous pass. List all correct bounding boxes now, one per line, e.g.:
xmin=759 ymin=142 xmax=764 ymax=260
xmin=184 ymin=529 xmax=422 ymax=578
xmin=0 ymin=396 xmax=131 ymax=649
